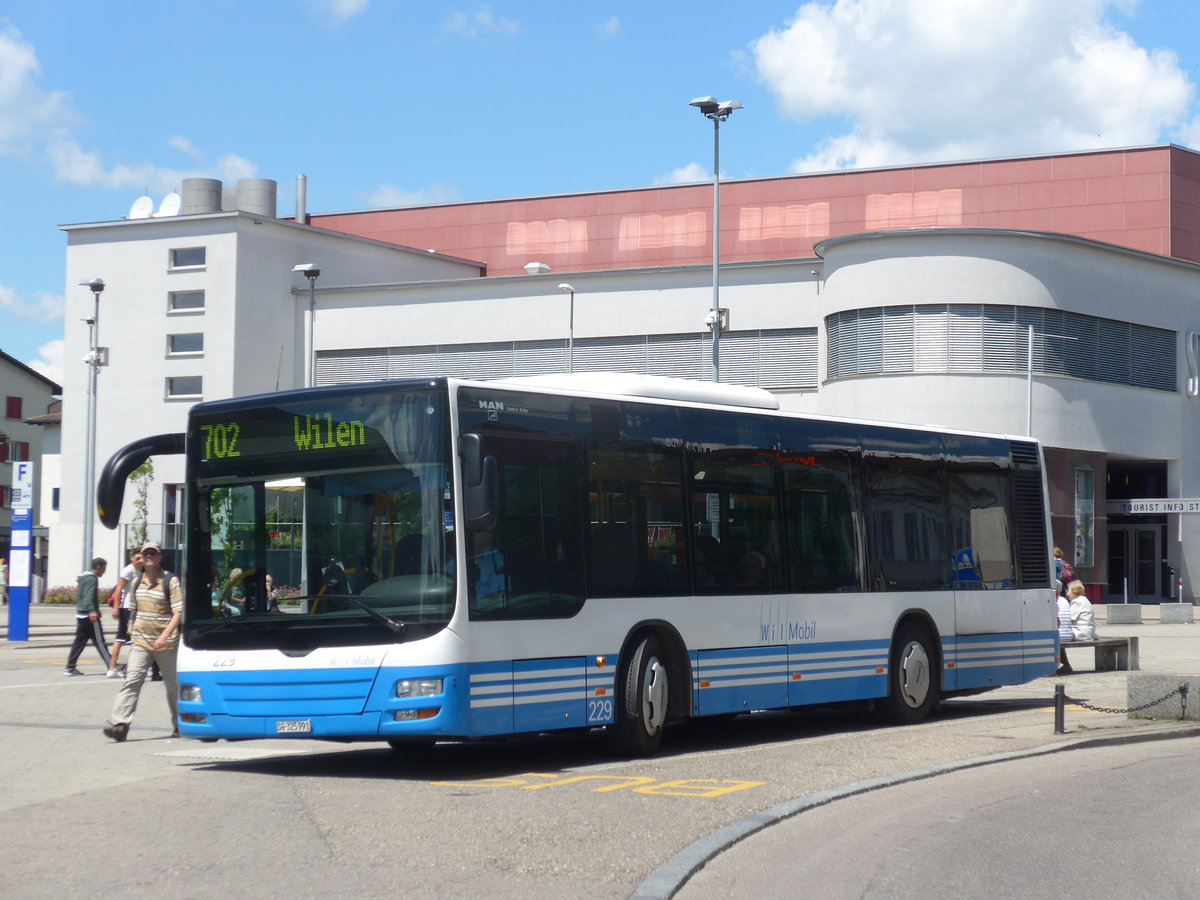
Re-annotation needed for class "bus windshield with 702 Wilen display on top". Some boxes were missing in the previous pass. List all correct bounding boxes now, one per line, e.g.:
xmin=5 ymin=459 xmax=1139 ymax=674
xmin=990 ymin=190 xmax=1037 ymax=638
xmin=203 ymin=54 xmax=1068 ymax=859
xmin=184 ymin=385 xmax=455 ymax=650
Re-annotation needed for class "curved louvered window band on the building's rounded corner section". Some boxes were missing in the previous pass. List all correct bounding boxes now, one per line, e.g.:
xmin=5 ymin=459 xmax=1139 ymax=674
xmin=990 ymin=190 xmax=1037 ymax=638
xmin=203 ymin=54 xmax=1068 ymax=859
xmin=826 ymin=304 xmax=1176 ymax=391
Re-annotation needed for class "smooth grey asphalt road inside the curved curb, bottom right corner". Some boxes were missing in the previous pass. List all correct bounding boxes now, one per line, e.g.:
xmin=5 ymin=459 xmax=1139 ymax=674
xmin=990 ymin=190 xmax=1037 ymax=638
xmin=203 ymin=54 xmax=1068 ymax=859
xmin=676 ymin=738 xmax=1200 ymax=900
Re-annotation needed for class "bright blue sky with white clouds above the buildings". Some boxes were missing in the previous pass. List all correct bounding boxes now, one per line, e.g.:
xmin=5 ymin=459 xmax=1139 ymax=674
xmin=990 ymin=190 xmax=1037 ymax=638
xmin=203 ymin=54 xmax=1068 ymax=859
xmin=0 ymin=0 xmax=1200 ymax=380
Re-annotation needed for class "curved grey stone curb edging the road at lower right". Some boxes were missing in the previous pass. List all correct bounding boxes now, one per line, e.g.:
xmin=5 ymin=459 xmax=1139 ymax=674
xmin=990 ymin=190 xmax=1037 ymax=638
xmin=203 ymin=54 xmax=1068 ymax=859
xmin=630 ymin=725 xmax=1200 ymax=900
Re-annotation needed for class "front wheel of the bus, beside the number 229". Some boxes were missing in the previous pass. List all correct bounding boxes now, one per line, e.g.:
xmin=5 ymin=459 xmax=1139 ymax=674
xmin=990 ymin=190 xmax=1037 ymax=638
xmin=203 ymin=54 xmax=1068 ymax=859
xmin=608 ymin=635 xmax=671 ymax=756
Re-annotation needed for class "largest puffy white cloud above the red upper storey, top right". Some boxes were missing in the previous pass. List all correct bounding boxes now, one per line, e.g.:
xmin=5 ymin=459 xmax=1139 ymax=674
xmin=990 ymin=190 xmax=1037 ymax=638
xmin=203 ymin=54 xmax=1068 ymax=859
xmin=750 ymin=0 xmax=1195 ymax=172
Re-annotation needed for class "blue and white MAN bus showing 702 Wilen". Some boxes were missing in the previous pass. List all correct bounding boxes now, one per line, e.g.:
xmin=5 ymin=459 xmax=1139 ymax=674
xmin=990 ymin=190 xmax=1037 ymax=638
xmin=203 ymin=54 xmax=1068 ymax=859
xmin=105 ymin=374 xmax=1057 ymax=755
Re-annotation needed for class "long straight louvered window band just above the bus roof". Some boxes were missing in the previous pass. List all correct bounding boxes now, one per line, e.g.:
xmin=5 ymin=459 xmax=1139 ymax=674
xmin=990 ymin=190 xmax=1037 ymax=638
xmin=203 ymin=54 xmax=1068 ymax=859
xmin=316 ymin=328 xmax=817 ymax=390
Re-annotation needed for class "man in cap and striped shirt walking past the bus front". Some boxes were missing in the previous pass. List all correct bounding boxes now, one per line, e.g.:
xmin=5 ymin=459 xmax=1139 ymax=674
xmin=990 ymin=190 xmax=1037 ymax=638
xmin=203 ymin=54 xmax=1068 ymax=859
xmin=104 ymin=542 xmax=184 ymax=740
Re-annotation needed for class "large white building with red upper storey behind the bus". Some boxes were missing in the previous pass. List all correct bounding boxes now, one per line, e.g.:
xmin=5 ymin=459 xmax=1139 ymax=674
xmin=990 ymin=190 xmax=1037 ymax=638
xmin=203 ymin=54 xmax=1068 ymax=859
xmin=58 ymin=148 xmax=1200 ymax=601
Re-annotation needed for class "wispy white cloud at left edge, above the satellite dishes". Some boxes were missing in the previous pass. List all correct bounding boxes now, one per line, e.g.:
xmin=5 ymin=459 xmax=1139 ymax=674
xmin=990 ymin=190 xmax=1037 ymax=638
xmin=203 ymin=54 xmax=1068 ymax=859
xmin=0 ymin=20 xmax=256 ymax=191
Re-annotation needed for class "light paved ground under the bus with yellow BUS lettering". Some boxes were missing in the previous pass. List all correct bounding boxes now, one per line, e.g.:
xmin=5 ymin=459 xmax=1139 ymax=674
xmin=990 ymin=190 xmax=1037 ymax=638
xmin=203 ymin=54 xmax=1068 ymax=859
xmin=0 ymin=610 xmax=1200 ymax=900
